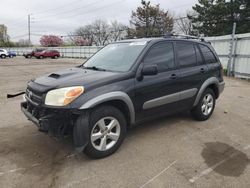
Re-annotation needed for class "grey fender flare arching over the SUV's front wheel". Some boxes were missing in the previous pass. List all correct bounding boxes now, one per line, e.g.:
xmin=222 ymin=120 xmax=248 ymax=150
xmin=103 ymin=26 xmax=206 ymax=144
xmin=79 ymin=91 xmax=135 ymax=124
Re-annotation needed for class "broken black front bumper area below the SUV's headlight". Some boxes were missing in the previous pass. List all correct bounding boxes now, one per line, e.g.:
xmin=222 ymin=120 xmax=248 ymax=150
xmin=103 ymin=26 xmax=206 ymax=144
xmin=21 ymin=101 xmax=89 ymax=152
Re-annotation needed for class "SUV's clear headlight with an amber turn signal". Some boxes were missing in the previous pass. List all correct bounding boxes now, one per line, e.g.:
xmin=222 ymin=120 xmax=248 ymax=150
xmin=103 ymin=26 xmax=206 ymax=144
xmin=45 ymin=86 xmax=84 ymax=106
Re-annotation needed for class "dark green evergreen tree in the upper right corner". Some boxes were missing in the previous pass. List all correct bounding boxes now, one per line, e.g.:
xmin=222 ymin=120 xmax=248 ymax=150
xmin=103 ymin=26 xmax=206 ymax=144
xmin=188 ymin=0 xmax=250 ymax=36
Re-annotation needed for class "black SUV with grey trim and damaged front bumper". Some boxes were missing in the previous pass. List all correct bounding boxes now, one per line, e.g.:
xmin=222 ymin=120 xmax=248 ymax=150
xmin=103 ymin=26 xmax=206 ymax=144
xmin=21 ymin=37 xmax=224 ymax=158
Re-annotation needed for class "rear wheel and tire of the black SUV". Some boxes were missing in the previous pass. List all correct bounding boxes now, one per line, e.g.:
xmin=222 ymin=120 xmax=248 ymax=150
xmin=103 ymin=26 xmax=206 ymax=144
xmin=191 ymin=88 xmax=216 ymax=121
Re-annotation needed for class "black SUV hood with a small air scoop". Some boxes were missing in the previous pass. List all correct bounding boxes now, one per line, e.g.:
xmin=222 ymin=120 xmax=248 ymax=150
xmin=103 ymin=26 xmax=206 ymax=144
xmin=28 ymin=67 xmax=119 ymax=93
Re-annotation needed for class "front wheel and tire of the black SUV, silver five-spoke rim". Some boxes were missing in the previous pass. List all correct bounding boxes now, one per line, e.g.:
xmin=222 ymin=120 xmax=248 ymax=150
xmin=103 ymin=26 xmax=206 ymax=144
xmin=84 ymin=106 xmax=127 ymax=159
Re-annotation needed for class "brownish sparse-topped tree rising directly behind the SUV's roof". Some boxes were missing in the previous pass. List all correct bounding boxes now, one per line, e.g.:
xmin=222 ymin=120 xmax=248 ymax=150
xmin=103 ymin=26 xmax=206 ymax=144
xmin=128 ymin=0 xmax=173 ymax=38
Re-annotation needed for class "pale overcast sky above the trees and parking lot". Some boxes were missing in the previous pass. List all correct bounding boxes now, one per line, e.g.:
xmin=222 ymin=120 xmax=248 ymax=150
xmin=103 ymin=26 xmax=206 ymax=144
xmin=0 ymin=0 xmax=197 ymax=44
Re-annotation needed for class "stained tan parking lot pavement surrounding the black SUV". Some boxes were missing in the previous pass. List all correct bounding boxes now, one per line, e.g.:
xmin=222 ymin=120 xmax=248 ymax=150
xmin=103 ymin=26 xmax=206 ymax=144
xmin=0 ymin=57 xmax=250 ymax=188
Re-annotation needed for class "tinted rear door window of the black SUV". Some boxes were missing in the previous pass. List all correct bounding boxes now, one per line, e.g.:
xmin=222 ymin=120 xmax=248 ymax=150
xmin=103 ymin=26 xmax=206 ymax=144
xmin=176 ymin=42 xmax=197 ymax=67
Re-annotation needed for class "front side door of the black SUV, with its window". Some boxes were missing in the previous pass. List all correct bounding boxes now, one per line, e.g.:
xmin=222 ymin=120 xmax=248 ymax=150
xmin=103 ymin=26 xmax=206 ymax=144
xmin=135 ymin=41 xmax=181 ymax=121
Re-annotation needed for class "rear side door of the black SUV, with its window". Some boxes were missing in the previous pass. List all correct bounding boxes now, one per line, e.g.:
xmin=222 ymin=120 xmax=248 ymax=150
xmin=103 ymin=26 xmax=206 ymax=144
xmin=175 ymin=41 xmax=209 ymax=108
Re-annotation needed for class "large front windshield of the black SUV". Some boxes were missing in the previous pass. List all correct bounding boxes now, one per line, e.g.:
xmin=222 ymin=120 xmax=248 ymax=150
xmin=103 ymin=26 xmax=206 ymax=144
xmin=84 ymin=41 xmax=146 ymax=72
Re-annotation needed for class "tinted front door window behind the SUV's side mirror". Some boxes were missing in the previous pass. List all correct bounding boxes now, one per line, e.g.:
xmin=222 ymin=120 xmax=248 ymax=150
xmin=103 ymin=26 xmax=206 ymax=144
xmin=144 ymin=42 xmax=175 ymax=72
